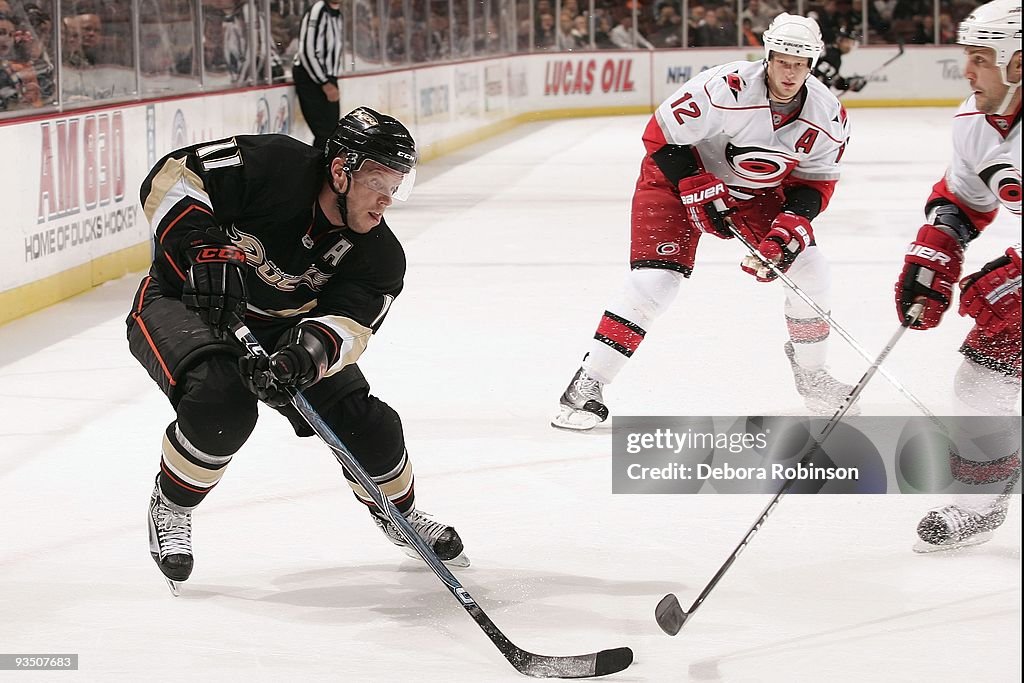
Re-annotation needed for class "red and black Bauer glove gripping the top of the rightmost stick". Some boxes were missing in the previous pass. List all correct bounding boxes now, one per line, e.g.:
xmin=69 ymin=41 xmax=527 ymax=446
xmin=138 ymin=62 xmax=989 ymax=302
xmin=895 ymin=224 xmax=964 ymax=330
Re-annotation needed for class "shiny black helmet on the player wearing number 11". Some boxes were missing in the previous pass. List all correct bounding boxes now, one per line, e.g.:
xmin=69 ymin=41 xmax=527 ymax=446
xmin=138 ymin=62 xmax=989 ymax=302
xmin=324 ymin=106 xmax=420 ymax=173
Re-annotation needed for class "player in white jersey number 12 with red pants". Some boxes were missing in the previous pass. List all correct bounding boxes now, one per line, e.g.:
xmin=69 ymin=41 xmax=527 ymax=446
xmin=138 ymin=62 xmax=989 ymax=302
xmin=552 ymin=13 xmax=852 ymax=430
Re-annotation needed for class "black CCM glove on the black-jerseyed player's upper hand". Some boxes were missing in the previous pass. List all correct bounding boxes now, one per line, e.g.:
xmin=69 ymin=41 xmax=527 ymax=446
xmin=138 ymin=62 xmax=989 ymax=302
xmin=181 ymin=244 xmax=248 ymax=337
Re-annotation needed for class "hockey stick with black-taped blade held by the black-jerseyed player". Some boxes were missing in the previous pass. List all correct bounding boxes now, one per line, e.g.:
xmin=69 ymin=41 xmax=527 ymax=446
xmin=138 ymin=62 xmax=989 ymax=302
xmin=234 ymin=324 xmax=633 ymax=678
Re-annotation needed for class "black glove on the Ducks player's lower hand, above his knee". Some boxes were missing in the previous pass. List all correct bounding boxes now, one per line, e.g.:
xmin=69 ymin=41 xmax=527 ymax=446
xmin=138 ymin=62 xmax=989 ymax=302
xmin=239 ymin=326 xmax=328 ymax=408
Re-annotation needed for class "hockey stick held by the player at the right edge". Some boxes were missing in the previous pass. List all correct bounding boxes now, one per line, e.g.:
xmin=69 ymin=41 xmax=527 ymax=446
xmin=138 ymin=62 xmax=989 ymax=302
xmin=654 ymin=303 xmax=925 ymax=636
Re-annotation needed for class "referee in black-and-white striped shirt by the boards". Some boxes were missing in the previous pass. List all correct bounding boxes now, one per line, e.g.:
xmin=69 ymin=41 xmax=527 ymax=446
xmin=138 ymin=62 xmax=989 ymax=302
xmin=292 ymin=0 xmax=344 ymax=150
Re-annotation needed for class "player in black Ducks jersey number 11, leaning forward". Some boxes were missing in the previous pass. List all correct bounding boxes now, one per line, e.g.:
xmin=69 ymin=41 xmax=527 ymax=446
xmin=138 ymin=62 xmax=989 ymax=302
xmin=127 ymin=108 xmax=468 ymax=587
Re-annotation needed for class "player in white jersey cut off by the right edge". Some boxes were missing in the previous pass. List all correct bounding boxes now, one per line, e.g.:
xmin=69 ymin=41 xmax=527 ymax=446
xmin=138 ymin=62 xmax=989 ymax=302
xmin=896 ymin=0 xmax=1021 ymax=552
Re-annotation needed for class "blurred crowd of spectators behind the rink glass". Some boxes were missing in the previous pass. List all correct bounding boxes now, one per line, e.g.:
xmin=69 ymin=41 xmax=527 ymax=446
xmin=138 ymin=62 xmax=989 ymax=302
xmin=0 ymin=0 xmax=977 ymax=113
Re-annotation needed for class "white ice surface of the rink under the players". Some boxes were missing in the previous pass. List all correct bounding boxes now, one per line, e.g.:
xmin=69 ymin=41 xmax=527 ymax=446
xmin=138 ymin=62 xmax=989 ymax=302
xmin=0 ymin=109 xmax=1021 ymax=682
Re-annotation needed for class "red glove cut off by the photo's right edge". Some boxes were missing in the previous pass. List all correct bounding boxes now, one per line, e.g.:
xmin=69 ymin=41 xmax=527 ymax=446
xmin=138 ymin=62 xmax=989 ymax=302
xmin=959 ymin=245 xmax=1021 ymax=334
